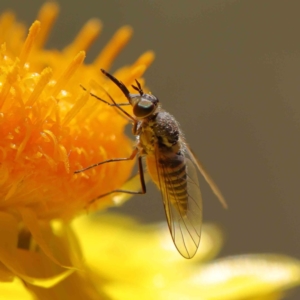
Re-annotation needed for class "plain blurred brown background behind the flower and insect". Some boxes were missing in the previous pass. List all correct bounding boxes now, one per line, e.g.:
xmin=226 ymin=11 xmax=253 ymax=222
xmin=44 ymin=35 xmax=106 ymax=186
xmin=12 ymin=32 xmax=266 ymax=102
xmin=0 ymin=0 xmax=300 ymax=299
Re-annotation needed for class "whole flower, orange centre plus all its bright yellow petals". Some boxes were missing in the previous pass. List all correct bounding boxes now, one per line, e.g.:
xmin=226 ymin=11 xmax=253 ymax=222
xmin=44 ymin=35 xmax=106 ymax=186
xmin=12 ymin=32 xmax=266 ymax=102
xmin=0 ymin=3 xmax=300 ymax=300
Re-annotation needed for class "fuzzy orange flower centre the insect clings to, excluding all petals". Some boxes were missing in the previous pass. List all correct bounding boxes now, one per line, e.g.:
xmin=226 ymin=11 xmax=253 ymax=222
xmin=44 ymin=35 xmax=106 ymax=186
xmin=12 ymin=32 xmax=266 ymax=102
xmin=0 ymin=4 xmax=153 ymax=219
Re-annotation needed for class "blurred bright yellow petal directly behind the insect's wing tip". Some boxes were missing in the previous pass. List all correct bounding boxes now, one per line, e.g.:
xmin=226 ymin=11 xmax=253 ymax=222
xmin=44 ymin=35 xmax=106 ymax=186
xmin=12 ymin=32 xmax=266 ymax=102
xmin=73 ymin=214 xmax=222 ymax=290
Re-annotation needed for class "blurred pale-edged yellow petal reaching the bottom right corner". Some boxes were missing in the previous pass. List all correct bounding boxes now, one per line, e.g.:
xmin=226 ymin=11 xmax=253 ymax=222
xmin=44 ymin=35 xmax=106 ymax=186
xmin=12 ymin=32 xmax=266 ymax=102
xmin=188 ymin=254 xmax=300 ymax=300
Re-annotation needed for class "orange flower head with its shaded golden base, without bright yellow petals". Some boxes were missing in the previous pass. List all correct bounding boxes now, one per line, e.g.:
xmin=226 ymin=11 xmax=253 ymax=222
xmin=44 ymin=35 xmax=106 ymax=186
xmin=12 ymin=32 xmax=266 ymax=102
xmin=0 ymin=3 xmax=154 ymax=287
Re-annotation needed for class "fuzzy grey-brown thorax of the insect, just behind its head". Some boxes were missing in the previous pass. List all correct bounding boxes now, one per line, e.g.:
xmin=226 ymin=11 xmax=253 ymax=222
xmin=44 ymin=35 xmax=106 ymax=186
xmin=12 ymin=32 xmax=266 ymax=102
xmin=138 ymin=111 xmax=181 ymax=155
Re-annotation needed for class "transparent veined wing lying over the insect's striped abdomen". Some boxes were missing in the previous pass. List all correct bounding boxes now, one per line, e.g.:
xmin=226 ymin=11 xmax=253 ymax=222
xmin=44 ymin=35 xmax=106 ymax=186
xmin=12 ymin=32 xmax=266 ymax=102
xmin=156 ymin=150 xmax=202 ymax=258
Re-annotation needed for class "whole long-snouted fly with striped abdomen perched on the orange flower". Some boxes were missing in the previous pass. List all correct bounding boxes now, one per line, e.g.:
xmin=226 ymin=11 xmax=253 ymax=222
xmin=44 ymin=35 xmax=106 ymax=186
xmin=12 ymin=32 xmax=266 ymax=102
xmin=75 ymin=69 xmax=227 ymax=258
